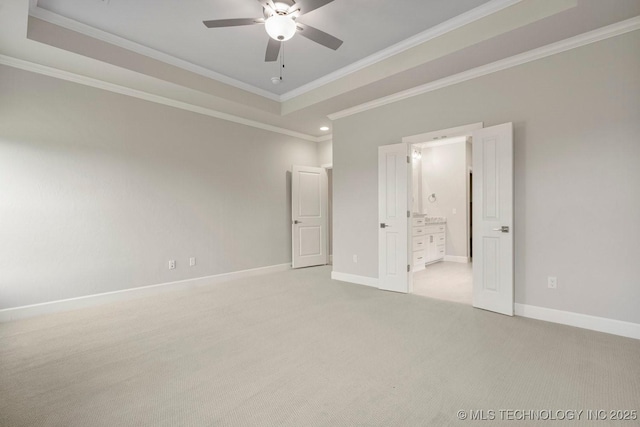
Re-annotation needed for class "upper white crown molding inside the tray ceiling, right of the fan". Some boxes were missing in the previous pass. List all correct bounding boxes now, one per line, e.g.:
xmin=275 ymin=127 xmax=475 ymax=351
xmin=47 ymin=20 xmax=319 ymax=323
xmin=280 ymin=0 xmax=522 ymax=101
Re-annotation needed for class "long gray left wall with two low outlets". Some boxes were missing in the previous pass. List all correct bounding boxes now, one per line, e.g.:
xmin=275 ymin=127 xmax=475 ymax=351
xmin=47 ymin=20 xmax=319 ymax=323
xmin=0 ymin=66 xmax=317 ymax=309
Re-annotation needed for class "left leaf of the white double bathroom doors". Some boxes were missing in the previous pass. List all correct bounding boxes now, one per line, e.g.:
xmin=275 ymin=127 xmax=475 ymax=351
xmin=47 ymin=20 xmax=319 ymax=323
xmin=378 ymin=143 xmax=411 ymax=293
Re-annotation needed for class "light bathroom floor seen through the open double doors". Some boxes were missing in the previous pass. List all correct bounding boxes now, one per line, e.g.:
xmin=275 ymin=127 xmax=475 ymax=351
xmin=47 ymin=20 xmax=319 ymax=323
xmin=413 ymin=261 xmax=473 ymax=305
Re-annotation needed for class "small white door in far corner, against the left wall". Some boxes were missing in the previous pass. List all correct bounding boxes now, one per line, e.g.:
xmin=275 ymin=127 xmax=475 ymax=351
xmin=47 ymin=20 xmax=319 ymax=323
xmin=291 ymin=166 xmax=329 ymax=268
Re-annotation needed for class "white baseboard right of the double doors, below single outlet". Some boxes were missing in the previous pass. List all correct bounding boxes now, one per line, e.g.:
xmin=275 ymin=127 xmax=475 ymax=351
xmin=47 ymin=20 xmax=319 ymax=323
xmin=515 ymin=304 xmax=640 ymax=339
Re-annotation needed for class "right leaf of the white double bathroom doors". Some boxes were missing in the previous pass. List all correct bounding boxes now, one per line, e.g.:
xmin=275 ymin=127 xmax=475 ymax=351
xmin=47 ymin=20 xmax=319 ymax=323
xmin=472 ymin=123 xmax=513 ymax=316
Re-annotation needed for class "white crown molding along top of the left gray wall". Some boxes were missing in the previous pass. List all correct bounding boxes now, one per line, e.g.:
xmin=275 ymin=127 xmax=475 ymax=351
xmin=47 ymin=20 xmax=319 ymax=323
xmin=0 ymin=54 xmax=318 ymax=142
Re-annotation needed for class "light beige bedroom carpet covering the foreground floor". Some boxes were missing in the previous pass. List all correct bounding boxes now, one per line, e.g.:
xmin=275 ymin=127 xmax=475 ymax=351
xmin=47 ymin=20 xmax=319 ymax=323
xmin=0 ymin=267 xmax=640 ymax=427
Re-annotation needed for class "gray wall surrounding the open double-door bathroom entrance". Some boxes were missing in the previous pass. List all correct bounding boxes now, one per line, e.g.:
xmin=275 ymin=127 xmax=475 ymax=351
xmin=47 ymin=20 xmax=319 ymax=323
xmin=333 ymin=31 xmax=640 ymax=323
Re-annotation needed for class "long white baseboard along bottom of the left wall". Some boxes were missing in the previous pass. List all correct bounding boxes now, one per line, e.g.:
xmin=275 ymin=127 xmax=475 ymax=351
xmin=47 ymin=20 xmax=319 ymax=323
xmin=0 ymin=263 xmax=291 ymax=323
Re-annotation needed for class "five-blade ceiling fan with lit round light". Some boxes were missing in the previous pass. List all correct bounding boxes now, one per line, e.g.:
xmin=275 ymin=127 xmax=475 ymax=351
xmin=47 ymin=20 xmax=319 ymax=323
xmin=202 ymin=0 xmax=342 ymax=62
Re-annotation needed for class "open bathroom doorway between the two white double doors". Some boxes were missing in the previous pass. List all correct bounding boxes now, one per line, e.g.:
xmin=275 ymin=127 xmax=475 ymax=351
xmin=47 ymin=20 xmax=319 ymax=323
xmin=411 ymin=135 xmax=473 ymax=305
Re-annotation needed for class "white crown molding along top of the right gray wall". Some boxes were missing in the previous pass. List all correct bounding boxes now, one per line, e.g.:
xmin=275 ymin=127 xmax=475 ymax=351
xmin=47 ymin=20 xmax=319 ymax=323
xmin=327 ymin=16 xmax=640 ymax=120
